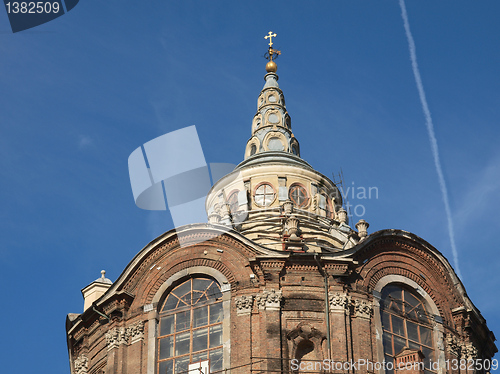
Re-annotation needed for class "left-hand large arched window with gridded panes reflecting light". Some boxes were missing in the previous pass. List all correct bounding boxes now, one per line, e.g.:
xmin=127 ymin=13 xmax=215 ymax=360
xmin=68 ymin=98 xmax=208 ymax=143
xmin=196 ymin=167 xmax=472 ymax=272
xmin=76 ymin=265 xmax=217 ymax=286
xmin=158 ymin=276 xmax=224 ymax=374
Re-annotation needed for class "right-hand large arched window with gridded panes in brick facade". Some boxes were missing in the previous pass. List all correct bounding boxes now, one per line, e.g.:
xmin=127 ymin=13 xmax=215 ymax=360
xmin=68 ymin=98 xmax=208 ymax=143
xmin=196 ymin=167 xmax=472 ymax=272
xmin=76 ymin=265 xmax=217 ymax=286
xmin=380 ymin=284 xmax=435 ymax=373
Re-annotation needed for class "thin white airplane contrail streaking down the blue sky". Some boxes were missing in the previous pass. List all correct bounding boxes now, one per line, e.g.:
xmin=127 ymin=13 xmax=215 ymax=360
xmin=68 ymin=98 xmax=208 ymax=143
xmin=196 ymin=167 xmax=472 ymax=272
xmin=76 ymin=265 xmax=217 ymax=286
xmin=399 ymin=0 xmax=462 ymax=278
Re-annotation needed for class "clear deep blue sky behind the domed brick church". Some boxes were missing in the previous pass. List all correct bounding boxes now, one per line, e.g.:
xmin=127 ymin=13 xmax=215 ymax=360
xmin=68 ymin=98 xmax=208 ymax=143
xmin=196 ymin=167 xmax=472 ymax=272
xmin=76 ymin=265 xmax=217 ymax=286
xmin=0 ymin=0 xmax=500 ymax=373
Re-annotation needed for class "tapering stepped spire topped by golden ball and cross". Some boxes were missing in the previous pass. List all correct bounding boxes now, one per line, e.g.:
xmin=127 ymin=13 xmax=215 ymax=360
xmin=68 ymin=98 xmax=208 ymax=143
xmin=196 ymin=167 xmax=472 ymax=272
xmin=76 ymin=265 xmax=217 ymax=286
xmin=245 ymin=31 xmax=300 ymax=159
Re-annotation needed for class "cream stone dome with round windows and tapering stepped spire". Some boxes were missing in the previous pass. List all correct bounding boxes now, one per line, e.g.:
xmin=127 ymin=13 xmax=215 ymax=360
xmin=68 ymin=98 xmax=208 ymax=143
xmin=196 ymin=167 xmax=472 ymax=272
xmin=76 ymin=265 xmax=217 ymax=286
xmin=206 ymin=56 xmax=368 ymax=252
